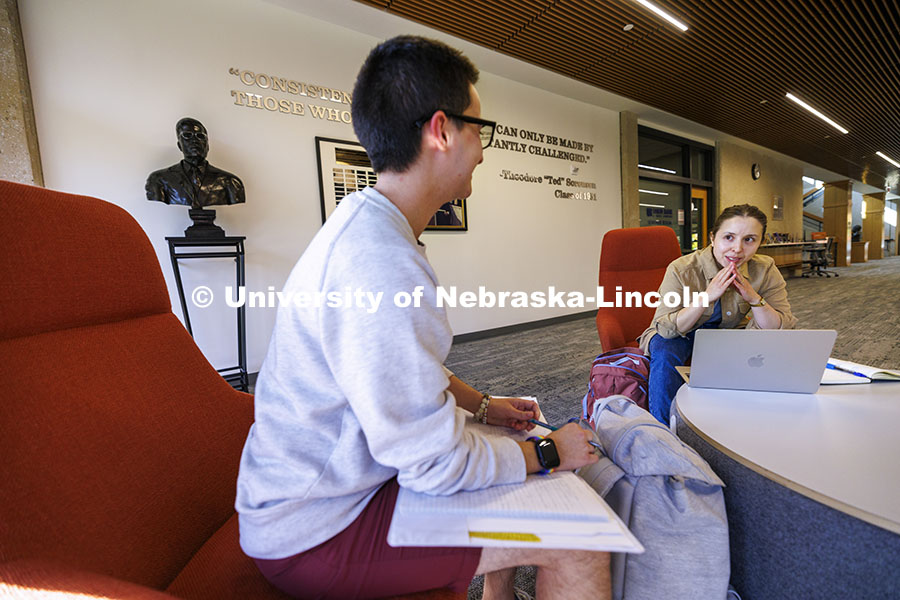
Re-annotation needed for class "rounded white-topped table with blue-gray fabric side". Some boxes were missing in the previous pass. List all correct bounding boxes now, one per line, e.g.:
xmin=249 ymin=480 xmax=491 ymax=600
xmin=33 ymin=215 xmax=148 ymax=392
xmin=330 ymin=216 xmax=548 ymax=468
xmin=673 ymin=382 xmax=900 ymax=600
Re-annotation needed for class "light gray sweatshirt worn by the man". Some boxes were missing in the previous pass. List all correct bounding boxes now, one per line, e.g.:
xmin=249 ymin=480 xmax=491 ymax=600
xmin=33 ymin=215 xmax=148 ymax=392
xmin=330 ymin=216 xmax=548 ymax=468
xmin=235 ymin=188 xmax=525 ymax=559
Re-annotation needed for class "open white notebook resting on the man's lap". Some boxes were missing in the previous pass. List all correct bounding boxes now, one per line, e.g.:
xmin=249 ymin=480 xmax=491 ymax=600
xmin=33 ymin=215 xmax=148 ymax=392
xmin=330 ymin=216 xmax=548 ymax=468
xmin=387 ymin=398 xmax=644 ymax=552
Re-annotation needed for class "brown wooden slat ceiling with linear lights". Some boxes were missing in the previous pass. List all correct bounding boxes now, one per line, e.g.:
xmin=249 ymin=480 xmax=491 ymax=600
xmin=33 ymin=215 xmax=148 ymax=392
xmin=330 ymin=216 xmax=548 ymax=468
xmin=358 ymin=0 xmax=900 ymax=194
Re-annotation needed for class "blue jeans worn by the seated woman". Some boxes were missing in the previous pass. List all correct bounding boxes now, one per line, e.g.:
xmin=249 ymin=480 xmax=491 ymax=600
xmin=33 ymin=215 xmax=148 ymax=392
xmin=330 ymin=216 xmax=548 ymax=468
xmin=647 ymin=301 xmax=722 ymax=427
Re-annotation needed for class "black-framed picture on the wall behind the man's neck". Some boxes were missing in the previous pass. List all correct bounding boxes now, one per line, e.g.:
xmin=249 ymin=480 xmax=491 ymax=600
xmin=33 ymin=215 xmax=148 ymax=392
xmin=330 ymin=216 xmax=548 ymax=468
xmin=316 ymin=136 xmax=469 ymax=231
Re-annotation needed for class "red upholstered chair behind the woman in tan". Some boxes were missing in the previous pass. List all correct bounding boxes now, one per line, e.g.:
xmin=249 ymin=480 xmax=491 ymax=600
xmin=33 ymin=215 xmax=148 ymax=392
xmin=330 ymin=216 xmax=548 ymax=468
xmin=597 ymin=227 xmax=681 ymax=352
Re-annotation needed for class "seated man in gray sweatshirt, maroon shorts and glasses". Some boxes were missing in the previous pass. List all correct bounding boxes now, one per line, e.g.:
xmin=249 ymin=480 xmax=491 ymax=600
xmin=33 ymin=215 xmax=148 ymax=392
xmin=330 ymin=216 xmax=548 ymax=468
xmin=236 ymin=36 xmax=609 ymax=600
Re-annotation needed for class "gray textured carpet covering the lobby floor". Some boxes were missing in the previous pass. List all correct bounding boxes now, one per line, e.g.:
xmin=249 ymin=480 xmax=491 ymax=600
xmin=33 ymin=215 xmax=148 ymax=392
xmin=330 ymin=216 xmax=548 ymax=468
xmin=447 ymin=256 xmax=900 ymax=600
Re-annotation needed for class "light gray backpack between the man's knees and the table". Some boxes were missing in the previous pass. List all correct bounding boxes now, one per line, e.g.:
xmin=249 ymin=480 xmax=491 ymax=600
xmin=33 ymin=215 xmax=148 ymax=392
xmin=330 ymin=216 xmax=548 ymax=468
xmin=577 ymin=396 xmax=731 ymax=600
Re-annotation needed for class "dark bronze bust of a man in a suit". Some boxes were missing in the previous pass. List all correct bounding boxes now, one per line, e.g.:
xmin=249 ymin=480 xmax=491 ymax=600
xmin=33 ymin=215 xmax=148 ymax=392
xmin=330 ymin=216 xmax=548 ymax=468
xmin=144 ymin=117 xmax=245 ymax=237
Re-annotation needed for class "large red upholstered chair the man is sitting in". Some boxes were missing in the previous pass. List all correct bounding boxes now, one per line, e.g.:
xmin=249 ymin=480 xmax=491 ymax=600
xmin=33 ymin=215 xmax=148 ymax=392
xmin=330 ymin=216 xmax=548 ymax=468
xmin=0 ymin=181 xmax=465 ymax=600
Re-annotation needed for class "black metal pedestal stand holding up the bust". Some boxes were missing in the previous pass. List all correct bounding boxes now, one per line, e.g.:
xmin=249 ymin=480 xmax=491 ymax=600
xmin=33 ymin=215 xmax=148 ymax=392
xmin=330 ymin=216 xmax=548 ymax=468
xmin=166 ymin=236 xmax=250 ymax=392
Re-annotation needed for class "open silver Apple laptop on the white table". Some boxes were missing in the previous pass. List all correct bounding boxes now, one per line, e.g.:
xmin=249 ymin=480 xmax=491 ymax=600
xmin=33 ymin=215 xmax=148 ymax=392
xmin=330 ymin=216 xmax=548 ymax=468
xmin=688 ymin=329 xmax=837 ymax=394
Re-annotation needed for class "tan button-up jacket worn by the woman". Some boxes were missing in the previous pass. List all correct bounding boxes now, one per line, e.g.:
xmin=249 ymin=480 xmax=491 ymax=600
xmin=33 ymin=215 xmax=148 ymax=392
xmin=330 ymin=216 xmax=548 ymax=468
xmin=639 ymin=246 xmax=797 ymax=352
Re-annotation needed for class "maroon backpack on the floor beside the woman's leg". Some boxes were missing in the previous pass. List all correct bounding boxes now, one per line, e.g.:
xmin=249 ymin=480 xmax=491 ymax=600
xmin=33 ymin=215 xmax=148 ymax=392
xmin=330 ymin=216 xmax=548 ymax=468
xmin=582 ymin=348 xmax=650 ymax=418
